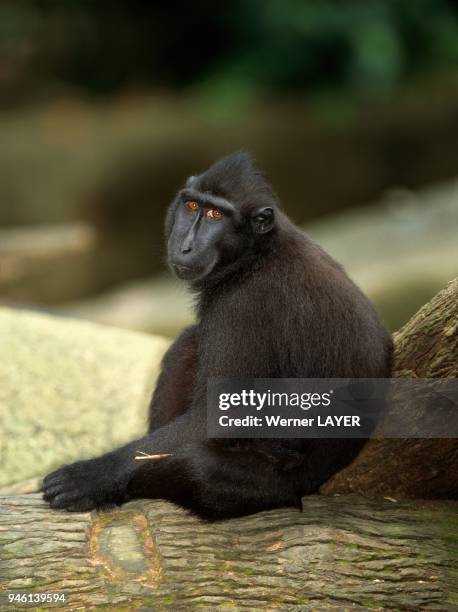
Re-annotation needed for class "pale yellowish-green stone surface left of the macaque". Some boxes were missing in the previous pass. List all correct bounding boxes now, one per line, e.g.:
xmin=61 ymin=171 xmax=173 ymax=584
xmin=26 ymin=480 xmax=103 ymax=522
xmin=0 ymin=309 xmax=168 ymax=486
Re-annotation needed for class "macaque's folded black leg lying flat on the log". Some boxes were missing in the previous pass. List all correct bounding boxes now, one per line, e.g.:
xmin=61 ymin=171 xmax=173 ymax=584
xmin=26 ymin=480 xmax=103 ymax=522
xmin=127 ymin=442 xmax=302 ymax=520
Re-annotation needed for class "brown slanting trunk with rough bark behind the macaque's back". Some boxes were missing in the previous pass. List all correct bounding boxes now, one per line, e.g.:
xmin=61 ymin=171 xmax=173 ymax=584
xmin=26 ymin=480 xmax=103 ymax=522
xmin=321 ymin=279 xmax=458 ymax=499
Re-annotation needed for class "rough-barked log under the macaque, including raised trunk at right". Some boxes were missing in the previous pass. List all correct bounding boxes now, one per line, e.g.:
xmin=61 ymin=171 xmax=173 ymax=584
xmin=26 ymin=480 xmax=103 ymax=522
xmin=0 ymin=281 xmax=458 ymax=611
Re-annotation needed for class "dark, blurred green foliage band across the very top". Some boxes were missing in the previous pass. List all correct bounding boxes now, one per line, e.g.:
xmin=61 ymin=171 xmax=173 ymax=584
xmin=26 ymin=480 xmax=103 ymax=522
xmin=0 ymin=0 xmax=458 ymax=105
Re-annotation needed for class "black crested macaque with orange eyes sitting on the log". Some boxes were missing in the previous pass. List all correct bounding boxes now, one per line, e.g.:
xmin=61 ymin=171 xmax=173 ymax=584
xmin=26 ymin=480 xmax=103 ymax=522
xmin=43 ymin=152 xmax=392 ymax=520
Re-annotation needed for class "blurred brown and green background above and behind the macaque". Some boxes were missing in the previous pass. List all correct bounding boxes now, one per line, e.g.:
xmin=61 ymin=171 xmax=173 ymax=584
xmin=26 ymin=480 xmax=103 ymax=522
xmin=0 ymin=0 xmax=458 ymax=336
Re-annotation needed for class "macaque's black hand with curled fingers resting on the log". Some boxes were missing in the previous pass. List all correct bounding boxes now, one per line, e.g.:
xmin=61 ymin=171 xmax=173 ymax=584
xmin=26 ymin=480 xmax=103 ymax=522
xmin=42 ymin=457 xmax=128 ymax=512
